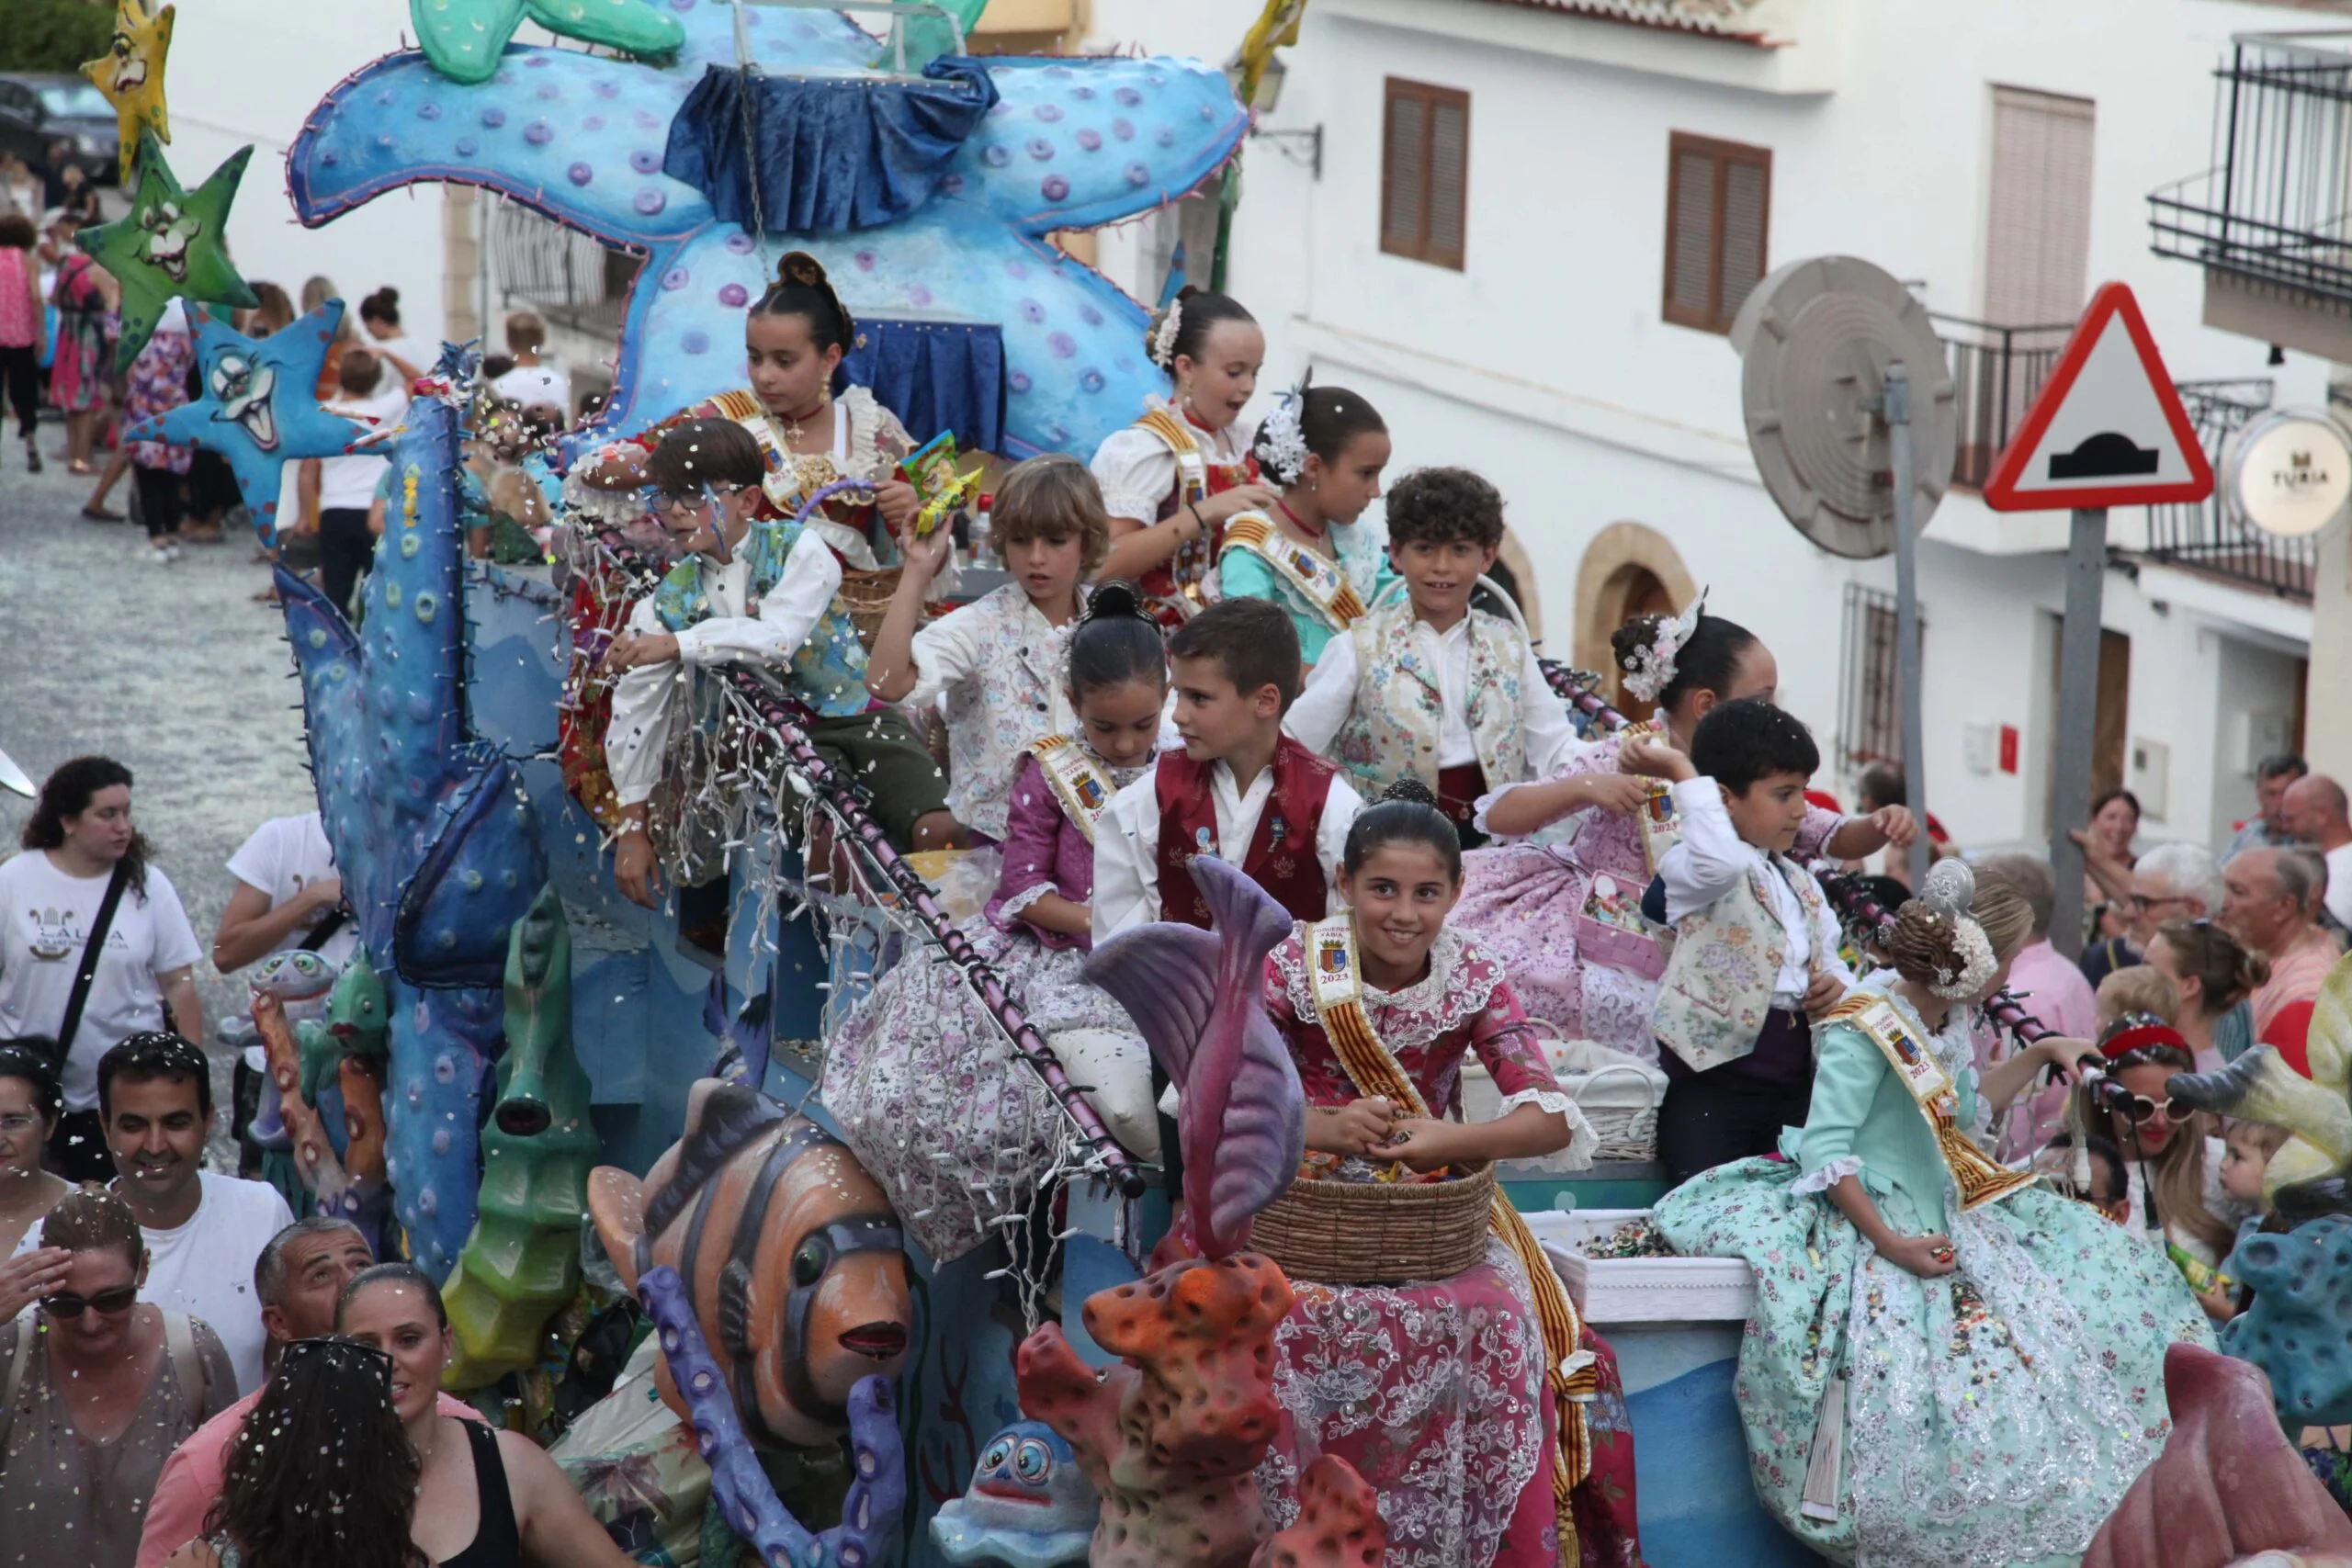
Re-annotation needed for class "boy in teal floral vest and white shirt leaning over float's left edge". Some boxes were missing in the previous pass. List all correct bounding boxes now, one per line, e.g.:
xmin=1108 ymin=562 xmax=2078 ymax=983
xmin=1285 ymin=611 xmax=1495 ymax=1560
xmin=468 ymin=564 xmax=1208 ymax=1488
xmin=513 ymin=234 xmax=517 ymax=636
xmin=605 ymin=419 xmax=957 ymax=908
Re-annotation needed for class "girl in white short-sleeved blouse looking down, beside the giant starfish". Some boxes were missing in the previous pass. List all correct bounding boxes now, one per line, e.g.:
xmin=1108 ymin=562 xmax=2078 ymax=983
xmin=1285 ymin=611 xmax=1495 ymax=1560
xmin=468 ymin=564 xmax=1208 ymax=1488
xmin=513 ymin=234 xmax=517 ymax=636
xmin=1093 ymin=287 xmax=1275 ymax=630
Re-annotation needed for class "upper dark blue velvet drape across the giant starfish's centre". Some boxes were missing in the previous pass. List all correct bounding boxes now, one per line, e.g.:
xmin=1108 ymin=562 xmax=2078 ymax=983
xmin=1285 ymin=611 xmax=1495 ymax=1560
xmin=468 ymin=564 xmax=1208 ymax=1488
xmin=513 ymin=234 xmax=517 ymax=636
xmin=663 ymin=54 xmax=997 ymax=235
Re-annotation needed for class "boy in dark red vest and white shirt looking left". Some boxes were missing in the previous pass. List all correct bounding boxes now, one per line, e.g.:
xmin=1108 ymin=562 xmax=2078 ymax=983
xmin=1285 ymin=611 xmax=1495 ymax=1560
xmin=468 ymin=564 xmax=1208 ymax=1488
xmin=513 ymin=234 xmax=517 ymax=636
xmin=1093 ymin=600 xmax=1362 ymax=942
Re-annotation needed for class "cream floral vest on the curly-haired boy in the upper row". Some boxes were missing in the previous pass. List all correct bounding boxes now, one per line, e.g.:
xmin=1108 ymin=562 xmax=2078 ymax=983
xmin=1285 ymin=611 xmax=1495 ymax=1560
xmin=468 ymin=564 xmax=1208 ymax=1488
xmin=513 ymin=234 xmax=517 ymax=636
xmin=1331 ymin=600 xmax=1529 ymax=799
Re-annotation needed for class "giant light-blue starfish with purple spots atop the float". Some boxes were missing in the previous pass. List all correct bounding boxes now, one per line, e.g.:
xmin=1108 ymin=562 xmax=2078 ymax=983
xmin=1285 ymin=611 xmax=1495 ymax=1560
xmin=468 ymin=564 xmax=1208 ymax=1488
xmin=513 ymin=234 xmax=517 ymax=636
xmin=287 ymin=0 xmax=1249 ymax=456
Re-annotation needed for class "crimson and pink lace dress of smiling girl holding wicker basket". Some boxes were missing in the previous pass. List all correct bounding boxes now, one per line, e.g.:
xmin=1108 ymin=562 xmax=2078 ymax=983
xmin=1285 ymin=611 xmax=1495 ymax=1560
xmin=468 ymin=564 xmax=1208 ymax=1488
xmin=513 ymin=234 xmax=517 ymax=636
xmin=1259 ymin=912 xmax=1634 ymax=1568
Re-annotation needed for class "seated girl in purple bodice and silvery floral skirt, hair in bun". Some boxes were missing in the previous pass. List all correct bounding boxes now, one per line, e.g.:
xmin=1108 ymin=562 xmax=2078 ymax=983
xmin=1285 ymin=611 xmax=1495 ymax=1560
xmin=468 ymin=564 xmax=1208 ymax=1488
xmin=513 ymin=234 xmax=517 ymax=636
xmin=823 ymin=585 xmax=1169 ymax=1265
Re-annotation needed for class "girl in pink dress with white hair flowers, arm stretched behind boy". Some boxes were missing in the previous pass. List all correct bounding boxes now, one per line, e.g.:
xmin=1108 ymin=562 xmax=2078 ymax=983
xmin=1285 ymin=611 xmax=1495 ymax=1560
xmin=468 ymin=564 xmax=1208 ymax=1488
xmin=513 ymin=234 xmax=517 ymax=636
xmin=1453 ymin=594 xmax=1915 ymax=1063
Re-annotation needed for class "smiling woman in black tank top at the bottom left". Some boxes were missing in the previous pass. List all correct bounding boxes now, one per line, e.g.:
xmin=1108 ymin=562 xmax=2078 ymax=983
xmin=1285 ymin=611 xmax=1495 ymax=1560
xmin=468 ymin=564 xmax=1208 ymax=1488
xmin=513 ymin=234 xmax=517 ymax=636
xmin=331 ymin=1262 xmax=633 ymax=1568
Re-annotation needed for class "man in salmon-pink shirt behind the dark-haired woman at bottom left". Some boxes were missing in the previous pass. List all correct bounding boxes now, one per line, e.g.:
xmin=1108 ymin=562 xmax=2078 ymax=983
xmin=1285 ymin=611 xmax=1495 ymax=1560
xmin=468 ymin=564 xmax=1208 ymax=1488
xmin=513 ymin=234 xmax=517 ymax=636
xmin=136 ymin=1218 xmax=482 ymax=1568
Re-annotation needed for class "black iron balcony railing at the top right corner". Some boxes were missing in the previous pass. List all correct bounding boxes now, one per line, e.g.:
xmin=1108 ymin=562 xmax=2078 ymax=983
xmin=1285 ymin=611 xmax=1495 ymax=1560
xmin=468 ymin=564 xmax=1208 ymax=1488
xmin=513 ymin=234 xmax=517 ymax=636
xmin=2147 ymin=33 xmax=2352 ymax=306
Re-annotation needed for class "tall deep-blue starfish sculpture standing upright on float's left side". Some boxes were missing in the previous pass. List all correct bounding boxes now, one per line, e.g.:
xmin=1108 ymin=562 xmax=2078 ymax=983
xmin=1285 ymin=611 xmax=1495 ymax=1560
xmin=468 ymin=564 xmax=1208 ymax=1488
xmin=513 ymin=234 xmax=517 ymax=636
xmin=277 ymin=383 xmax=546 ymax=1279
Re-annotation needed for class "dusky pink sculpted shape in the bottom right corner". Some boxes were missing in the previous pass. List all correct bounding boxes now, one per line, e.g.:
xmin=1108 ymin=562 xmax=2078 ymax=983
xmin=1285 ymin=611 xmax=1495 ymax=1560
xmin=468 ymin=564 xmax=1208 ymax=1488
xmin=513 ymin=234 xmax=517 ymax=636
xmin=2082 ymin=1345 xmax=2352 ymax=1568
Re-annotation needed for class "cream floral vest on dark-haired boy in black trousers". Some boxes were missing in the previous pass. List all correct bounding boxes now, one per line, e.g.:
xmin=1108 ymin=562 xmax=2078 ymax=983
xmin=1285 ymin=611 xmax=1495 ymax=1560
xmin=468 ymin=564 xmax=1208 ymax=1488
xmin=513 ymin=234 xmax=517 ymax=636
xmin=1651 ymin=856 xmax=1823 ymax=1072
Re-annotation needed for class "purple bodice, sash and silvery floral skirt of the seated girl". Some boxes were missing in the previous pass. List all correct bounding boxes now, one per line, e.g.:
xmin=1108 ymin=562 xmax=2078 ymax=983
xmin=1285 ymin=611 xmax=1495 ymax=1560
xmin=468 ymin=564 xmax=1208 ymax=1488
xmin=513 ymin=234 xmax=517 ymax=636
xmin=823 ymin=736 xmax=1155 ymax=1262
